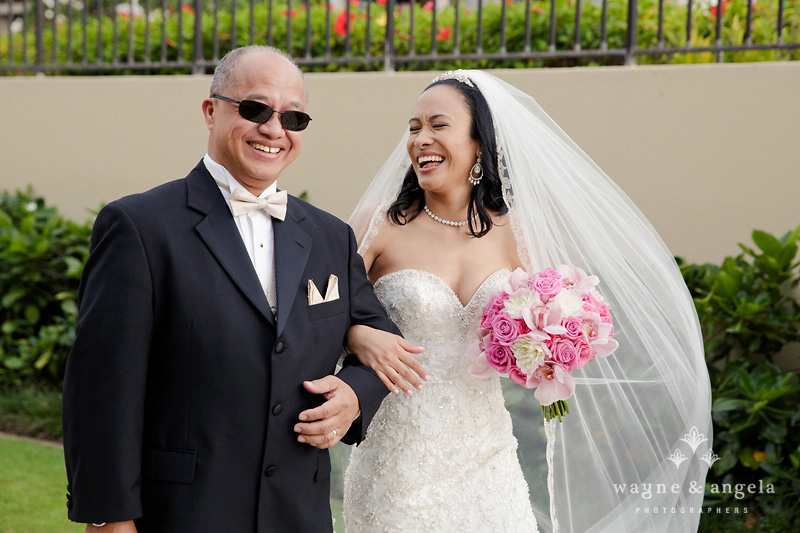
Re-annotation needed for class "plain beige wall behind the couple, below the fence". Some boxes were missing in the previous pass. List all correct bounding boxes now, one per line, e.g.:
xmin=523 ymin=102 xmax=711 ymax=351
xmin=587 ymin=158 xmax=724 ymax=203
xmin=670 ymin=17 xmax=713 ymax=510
xmin=0 ymin=63 xmax=800 ymax=262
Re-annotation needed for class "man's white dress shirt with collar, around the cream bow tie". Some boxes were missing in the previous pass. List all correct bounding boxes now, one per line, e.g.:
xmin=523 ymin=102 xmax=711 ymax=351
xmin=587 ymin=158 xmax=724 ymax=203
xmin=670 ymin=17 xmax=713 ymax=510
xmin=203 ymin=154 xmax=278 ymax=300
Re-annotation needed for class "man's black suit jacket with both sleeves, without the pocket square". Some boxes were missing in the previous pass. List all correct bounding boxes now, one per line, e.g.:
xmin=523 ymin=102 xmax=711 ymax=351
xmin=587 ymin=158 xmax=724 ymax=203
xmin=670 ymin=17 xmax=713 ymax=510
xmin=63 ymin=162 xmax=397 ymax=532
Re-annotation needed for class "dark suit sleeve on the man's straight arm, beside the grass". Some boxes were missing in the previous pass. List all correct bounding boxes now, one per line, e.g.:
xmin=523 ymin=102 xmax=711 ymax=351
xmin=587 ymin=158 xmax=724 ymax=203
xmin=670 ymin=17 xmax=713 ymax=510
xmin=63 ymin=204 xmax=153 ymax=522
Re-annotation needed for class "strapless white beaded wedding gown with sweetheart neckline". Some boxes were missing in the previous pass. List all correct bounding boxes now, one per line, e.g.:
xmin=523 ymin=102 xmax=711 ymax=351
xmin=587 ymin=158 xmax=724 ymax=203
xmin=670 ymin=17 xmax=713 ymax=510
xmin=344 ymin=270 xmax=537 ymax=533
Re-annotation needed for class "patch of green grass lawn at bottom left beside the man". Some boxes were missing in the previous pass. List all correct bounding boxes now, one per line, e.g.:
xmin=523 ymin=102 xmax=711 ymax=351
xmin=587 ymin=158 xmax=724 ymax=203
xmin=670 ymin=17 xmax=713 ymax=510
xmin=0 ymin=437 xmax=84 ymax=533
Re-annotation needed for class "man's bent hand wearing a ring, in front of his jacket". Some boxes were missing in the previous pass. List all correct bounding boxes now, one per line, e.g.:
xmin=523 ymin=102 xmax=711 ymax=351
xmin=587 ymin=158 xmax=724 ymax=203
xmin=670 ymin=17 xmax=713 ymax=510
xmin=294 ymin=376 xmax=359 ymax=449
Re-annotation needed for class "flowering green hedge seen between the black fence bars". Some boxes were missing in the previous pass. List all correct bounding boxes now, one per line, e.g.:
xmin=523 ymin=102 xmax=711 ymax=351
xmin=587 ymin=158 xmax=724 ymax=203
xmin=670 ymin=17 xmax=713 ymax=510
xmin=0 ymin=0 xmax=800 ymax=74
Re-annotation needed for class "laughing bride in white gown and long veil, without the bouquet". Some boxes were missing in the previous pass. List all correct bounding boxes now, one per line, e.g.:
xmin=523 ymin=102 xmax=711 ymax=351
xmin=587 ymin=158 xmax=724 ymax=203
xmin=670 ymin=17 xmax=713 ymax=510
xmin=344 ymin=71 xmax=711 ymax=532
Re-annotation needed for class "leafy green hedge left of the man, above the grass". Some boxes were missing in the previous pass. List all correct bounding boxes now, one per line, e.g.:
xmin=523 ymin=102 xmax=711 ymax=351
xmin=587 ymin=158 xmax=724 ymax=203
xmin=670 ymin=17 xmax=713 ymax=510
xmin=0 ymin=190 xmax=91 ymax=386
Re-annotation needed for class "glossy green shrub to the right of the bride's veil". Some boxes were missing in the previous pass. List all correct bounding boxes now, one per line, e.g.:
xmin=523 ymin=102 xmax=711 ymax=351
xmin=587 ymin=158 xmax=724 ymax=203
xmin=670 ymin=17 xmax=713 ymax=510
xmin=679 ymin=226 xmax=800 ymax=531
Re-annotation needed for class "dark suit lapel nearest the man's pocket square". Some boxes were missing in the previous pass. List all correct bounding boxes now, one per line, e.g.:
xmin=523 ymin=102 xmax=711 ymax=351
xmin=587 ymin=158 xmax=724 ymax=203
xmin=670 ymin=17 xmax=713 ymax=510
xmin=272 ymin=197 xmax=311 ymax=335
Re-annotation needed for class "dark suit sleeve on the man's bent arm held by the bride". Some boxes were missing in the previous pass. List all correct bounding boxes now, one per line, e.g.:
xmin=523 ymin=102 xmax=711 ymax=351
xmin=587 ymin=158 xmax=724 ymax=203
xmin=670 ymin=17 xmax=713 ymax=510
xmin=337 ymin=222 xmax=400 ymax=444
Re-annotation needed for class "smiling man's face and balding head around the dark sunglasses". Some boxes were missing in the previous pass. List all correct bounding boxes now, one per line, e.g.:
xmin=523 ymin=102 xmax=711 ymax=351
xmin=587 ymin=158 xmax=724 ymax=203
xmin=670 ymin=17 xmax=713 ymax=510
xmin=203 ymin=52 xmax=306 ymax=195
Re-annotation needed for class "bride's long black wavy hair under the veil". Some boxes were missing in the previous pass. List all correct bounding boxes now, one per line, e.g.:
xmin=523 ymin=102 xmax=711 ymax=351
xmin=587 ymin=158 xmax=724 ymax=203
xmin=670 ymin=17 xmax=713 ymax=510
xmin=388 ymin=79 xmax=508 ymax=237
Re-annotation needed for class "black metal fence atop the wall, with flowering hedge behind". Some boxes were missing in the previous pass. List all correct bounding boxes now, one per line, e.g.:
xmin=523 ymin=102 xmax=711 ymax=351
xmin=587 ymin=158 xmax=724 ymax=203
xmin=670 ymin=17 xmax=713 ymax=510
xmin=0 ymin=0 xmax=800 ymax=75
